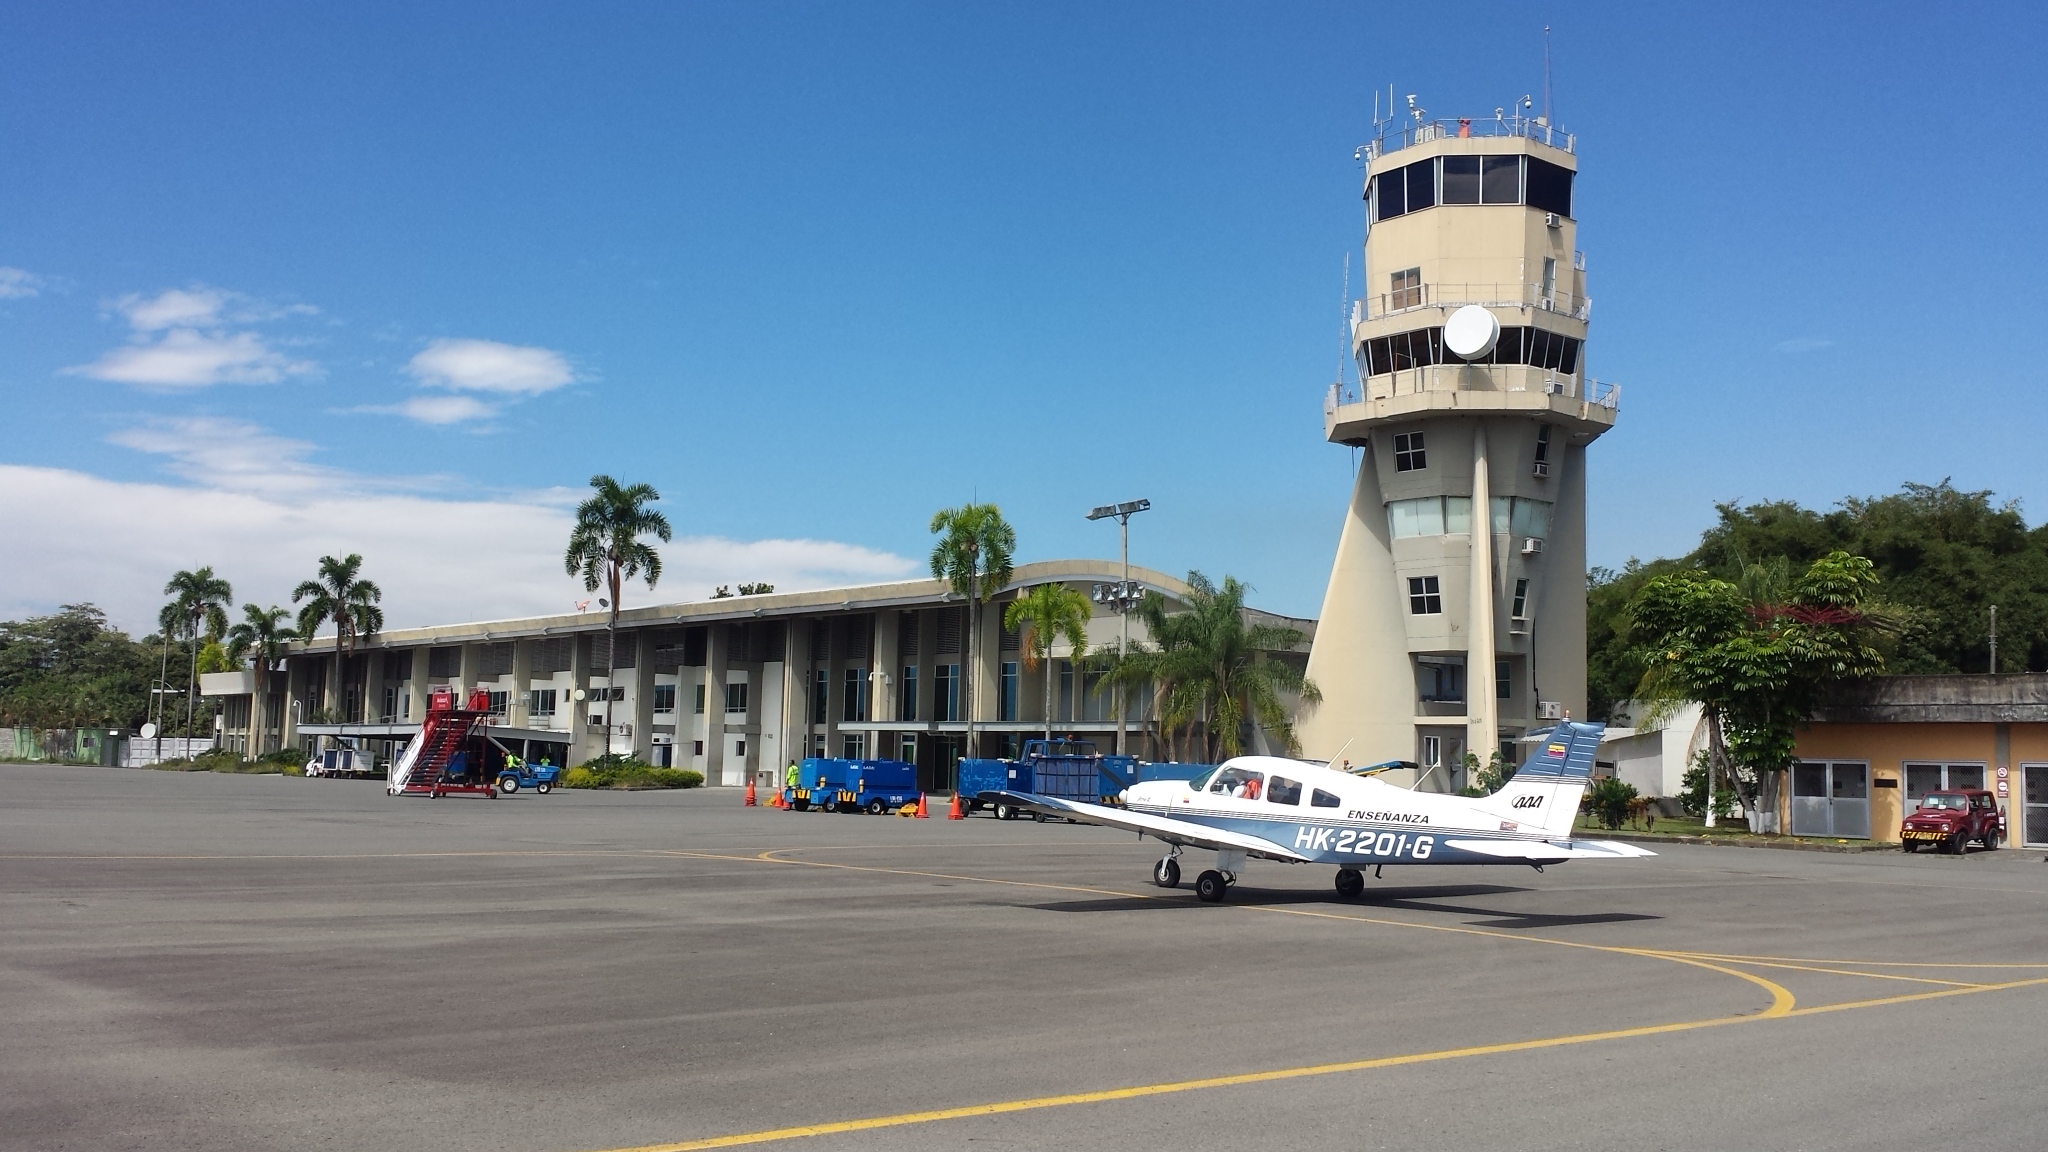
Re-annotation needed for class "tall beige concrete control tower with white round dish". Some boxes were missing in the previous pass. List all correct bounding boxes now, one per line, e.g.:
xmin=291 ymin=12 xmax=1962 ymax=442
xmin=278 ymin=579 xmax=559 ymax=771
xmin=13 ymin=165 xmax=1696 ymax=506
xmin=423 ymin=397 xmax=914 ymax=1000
xmin=1298 ymin=113 xmax=1620 ymax=791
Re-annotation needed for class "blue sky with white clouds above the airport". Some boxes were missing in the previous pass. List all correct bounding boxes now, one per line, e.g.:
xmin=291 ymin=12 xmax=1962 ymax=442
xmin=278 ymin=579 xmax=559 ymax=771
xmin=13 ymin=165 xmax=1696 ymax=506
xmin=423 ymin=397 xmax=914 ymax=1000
xmin=0 ymin=4 xmax=2048 ymax=623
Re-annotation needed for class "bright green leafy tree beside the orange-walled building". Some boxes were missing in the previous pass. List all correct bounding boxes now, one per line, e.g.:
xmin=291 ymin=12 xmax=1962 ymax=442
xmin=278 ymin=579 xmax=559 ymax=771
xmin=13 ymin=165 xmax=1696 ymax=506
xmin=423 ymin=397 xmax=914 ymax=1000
xmin=1628 ymin=551 xmax=1896 ymax=806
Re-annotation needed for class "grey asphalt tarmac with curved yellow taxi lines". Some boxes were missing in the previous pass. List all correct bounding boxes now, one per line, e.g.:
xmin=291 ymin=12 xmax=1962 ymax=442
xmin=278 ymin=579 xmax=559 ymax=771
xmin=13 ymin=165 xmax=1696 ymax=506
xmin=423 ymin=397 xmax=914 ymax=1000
xmin=12 ymin=765 xmax=2048 ymax=1152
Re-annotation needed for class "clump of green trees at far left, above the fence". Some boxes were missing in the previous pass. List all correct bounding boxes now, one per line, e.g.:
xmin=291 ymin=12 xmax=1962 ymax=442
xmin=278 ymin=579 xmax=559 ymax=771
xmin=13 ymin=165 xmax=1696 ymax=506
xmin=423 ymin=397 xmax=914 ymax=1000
xmin=0 ymin=605 xmax=156 ymax=728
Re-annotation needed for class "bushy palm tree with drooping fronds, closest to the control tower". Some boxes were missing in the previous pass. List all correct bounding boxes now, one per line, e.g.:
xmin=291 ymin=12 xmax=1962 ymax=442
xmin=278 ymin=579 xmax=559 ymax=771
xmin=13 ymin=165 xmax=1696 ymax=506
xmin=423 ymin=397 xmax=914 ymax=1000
xmin=1110 ymin=572 xmax=1323 ymax=758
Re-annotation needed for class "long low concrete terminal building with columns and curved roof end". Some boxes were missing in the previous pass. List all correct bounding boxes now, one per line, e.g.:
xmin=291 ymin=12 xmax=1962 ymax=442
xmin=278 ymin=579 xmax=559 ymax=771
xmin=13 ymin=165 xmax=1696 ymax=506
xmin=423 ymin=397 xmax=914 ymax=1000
xmin=203 ymin=560 xmax=1315 ymax=791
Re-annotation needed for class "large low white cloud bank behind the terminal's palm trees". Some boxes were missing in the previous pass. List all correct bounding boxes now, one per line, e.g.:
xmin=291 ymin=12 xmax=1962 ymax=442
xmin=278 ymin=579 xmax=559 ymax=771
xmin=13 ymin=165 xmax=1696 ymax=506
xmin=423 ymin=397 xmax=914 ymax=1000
xmin=0 ymin=420 xmax=918 ymax=633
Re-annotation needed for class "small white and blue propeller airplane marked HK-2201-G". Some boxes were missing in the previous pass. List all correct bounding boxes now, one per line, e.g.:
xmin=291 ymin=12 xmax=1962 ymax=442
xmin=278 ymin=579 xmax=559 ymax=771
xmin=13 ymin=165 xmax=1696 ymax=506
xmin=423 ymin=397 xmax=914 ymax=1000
xmin=979 ymin=719 xmax=1657 ymax=904
